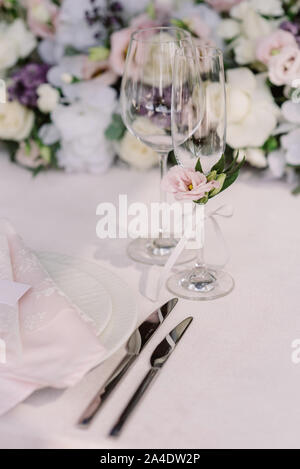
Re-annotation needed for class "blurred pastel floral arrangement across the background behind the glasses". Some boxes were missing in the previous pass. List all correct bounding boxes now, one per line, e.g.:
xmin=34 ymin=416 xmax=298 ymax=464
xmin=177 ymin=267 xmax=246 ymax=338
xmin=0 ymin=0 xmax=300 ymax=192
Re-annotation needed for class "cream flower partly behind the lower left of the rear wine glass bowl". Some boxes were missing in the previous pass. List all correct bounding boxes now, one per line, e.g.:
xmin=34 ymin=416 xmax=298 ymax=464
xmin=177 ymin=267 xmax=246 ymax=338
xmin=118 ymin=117 xmax=159 ymax=169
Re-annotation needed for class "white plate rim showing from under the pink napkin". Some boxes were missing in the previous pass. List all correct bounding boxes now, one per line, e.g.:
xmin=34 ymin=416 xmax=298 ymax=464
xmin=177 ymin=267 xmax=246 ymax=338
xmin=39 ymin=253 xmax=137 ymax=362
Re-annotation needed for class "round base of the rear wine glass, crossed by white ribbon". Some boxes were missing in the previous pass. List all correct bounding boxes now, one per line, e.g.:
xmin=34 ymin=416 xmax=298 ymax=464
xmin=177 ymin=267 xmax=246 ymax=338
xmin=127 ymin=238 xmax=196 ymax=265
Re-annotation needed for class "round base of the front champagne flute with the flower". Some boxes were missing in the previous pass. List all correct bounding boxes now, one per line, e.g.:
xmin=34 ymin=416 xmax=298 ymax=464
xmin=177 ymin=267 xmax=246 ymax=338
xmin=167 ymin=267 xmax=234 ymax=301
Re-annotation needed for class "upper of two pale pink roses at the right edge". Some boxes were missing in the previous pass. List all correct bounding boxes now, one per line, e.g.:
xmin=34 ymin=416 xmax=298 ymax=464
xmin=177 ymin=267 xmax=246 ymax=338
xmin=256 ymin=29 xmax=297 ymax=65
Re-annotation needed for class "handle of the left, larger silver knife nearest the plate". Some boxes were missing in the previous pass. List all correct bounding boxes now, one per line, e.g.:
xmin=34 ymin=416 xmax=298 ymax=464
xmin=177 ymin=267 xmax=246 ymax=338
xmin=78 ymin=354 xmax=136 ymax=428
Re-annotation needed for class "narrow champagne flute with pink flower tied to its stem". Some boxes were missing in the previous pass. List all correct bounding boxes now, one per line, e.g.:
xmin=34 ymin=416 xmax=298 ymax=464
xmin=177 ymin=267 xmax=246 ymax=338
xmin=167 ymin=46 xmax=234 ymax=300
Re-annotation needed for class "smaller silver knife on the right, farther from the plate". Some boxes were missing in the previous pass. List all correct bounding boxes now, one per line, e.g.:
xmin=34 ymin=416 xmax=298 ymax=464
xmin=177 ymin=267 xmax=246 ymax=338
xmin=110 ymin=317 xmax=193 ymax=436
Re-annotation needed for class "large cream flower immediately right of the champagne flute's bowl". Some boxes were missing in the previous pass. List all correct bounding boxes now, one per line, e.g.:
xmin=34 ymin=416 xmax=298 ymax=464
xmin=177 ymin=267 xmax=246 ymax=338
xmin=227 ymin=68 xmax=279 ymax=149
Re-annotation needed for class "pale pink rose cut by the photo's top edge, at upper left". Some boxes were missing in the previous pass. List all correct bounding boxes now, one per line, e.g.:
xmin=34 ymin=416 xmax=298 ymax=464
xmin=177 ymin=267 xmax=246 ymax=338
xmin=26 ymin=0 xmax=59 ymax=38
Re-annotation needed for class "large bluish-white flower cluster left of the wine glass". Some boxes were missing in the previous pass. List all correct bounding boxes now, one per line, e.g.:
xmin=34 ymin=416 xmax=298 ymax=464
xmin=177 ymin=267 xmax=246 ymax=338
xmin=52 ymin=82 xmax=116 ymax=173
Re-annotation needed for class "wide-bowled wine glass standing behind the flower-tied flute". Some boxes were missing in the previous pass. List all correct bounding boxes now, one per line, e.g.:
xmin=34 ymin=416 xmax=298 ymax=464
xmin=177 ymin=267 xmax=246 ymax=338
xmin=121 ymin=27 xmax=194 ymax=265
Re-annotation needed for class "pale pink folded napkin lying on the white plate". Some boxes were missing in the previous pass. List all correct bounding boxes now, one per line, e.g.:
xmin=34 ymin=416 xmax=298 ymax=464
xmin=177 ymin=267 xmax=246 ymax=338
xmin=0 ymin=221 xmax=105 ymax=415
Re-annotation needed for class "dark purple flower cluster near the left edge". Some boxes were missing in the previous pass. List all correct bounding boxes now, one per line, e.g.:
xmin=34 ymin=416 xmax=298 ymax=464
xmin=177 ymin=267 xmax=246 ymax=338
xmin=8 ymin=63 xmax=49 ymax=108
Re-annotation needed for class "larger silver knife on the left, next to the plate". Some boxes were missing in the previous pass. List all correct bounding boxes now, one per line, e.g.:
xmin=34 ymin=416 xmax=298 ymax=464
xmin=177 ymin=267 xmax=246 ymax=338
xmin=78 ymin=298 xmax=178 ymax=428
